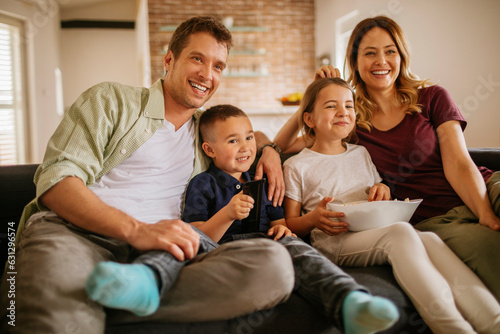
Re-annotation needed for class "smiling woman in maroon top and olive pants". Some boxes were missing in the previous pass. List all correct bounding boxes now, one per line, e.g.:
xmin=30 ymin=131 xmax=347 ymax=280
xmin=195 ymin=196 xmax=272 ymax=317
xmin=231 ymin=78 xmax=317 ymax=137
xmin=275 ymin=16 xmax=500 ymax=300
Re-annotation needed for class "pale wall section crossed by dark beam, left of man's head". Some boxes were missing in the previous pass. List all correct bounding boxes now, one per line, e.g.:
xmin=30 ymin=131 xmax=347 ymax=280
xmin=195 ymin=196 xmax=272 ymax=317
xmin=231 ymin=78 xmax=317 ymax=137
xmin=61 ymin=0 xmax=143 ymax=108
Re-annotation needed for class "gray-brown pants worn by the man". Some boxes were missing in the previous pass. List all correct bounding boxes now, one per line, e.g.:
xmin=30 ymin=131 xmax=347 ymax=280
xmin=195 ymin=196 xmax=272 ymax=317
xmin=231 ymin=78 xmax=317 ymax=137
xmin=0 ymin=212 xmax=295 ymax=334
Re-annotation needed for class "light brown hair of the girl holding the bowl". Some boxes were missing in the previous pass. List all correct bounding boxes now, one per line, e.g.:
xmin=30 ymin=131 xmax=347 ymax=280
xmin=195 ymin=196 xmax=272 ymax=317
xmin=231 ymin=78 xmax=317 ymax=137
xmin=298 ymin=78 xmax=356 ymax=142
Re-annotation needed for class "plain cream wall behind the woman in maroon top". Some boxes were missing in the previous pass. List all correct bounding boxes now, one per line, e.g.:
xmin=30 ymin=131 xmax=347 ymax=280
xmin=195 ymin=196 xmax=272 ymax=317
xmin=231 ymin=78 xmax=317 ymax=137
xmin=316 ymin=0 xmax=500 ymax=147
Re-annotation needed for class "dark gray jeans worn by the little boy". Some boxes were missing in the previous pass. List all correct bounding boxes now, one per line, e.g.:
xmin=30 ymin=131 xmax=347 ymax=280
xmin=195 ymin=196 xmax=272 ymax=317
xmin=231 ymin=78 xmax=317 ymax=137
xmin=139 ymin=228 xmax=367 ymax=328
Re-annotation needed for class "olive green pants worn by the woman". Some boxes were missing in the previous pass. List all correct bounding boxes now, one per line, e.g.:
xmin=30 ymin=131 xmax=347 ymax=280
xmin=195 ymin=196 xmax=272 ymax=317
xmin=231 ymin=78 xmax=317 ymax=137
xmin=415 ymin=172 xmax=500 ymax=301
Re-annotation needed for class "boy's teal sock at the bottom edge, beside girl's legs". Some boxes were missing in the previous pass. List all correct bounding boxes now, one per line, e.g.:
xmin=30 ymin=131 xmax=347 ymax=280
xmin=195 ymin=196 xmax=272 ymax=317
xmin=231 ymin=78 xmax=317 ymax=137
xmin=342 ymin=291 xmax=399 ymax=334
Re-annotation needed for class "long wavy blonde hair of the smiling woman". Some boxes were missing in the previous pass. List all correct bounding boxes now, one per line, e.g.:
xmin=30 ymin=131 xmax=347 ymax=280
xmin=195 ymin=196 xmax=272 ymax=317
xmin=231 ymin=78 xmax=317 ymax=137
xmin=346 ymin=16 xmax=431 ymax=130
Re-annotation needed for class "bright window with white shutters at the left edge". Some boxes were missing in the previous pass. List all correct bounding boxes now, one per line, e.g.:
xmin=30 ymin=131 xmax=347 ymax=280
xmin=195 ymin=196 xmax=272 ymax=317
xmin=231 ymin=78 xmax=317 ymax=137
xmin=0 ymin=15 xmax=28 ymax=165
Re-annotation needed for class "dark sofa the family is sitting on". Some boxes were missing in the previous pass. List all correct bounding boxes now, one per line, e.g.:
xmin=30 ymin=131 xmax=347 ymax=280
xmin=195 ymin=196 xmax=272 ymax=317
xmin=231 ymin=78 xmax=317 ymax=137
xmin=0 ymin=148 xmax=500 ymax=334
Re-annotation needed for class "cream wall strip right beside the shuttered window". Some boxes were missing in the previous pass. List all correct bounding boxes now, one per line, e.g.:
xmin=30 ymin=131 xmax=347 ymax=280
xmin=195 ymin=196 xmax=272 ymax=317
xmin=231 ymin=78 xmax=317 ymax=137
xmin=0 ymin=0 xmax=61 ymax=163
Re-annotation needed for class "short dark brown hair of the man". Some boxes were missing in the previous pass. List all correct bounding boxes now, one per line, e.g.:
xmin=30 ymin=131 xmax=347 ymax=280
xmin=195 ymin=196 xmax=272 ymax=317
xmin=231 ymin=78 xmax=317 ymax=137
xmin=168 ymin=16 xmax=233 ymax=58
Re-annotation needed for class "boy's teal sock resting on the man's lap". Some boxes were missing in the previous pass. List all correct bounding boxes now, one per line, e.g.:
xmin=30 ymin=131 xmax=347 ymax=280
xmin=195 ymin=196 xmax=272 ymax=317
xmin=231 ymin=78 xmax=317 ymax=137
xmin=85 ymin=262 xmax=160 ymax=316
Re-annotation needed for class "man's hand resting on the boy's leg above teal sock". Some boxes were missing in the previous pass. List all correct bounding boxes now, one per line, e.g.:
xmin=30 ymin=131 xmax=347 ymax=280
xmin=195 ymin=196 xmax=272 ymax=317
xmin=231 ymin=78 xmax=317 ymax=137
xmin=126 ymin=219 xmax=200 ymax=261
